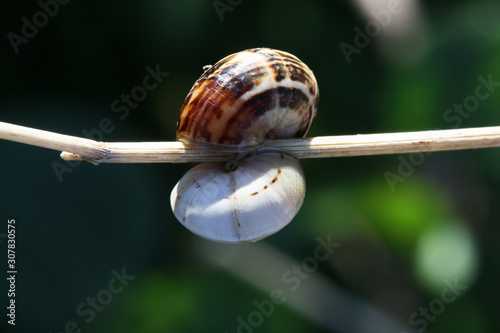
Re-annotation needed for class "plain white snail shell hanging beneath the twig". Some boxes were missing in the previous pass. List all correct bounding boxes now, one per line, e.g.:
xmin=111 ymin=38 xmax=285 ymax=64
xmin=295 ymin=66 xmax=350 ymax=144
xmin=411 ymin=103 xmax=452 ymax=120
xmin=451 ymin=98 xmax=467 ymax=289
xmin=170 ymin=148 xmax=305 ymax=243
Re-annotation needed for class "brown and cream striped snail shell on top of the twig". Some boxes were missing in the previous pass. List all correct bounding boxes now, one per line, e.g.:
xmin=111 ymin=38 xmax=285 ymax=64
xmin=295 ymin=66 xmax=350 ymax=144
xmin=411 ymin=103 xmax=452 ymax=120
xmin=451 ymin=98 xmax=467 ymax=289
xmin=177 ymin=48 xmax=319 ymax=148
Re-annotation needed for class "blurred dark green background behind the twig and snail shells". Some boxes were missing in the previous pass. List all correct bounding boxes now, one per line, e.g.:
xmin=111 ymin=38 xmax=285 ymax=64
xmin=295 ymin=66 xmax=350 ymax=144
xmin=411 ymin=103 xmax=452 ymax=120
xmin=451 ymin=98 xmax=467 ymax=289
xmin=0 ymin=0 xmax=500 ymax=333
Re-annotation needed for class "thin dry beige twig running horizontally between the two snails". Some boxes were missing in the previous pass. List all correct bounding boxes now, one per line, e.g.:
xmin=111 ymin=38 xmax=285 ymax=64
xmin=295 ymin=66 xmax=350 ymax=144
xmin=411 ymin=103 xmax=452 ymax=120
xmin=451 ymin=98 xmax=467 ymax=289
xmin=0 ymin=122 xmax=500 ymax=164
